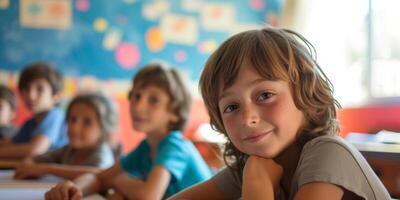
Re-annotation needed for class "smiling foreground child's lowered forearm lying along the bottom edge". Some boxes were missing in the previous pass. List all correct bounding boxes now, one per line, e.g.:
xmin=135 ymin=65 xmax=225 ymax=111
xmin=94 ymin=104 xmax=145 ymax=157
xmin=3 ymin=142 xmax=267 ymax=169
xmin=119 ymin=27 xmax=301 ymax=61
xmin=169 ymin=179 xmax=230 ymax=200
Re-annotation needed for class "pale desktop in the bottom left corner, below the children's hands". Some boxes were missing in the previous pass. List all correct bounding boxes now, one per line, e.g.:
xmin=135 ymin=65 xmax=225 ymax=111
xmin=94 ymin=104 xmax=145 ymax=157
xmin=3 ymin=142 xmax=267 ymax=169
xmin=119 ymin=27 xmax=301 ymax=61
xmin=0 ymin=170 xmax=104 ymax=200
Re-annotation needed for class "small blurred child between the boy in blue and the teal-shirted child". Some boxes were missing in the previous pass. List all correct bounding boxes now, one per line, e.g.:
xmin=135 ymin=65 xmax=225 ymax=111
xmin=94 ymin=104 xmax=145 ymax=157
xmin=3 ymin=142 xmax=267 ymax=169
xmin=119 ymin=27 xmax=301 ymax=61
xmin=14 ymin=93 xmax=118 ymax=180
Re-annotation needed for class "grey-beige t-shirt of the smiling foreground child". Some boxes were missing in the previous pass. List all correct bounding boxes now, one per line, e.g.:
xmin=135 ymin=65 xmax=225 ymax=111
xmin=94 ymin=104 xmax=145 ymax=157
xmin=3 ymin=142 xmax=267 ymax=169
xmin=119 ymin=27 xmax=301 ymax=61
xmin=212 ymin=136 xmax=390 ymax=200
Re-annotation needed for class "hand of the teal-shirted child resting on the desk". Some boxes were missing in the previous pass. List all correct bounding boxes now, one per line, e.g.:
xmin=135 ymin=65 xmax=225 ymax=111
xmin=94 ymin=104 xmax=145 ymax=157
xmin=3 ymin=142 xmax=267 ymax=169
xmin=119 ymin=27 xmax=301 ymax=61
xmin=44 ymin=181 xmax=83 ymax=200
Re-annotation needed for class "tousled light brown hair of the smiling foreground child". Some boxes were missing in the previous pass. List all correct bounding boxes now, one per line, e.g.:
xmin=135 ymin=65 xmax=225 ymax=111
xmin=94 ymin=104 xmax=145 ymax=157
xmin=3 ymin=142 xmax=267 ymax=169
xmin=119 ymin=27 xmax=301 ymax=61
xmin=200 ymin=27 xmax=340 ymax=173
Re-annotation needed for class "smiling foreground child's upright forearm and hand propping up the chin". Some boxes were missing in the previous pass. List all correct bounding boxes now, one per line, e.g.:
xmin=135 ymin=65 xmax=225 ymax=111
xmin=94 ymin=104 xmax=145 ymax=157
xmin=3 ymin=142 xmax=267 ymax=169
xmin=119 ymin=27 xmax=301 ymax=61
xmin=242 ymin=156 xmax=283 ymax=200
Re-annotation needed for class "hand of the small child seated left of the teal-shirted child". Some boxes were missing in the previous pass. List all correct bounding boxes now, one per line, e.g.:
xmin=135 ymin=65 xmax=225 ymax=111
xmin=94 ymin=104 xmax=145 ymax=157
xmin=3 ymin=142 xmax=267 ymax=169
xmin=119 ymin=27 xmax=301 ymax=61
xmin=14 ymin=161 xmax=44 ymax=179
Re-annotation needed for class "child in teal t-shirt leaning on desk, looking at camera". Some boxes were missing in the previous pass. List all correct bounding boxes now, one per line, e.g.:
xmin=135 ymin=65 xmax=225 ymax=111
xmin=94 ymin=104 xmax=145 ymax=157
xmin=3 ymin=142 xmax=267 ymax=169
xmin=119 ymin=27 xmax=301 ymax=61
xmin=45 ymin=64 xmax=211 ymax=199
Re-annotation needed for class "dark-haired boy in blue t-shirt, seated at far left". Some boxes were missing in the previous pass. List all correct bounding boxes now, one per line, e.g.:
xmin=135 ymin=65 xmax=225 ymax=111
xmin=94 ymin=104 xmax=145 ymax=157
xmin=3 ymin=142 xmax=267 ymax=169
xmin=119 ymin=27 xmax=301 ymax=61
xmin=0 ymin=62 xmax=68 ymax=158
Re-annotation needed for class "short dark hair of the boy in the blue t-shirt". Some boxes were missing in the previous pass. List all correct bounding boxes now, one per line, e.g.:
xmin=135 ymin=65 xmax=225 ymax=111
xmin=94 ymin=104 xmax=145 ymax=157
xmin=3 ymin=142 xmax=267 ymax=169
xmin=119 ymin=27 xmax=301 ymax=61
xmin=18 ymin=62 xmax=64 ymax=95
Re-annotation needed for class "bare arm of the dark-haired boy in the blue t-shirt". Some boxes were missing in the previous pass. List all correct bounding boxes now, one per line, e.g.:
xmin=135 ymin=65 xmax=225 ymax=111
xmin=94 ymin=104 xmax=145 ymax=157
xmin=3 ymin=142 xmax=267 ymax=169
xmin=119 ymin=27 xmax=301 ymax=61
xmin=0 ymin=134 xmax=50 ymax=158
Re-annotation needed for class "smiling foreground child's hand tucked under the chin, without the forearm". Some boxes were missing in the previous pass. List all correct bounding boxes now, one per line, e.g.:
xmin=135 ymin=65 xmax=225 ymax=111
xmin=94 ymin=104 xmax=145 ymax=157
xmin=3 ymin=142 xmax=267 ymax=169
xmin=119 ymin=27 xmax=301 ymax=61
xmin=243 ymin=155 xmax=283 ymax=191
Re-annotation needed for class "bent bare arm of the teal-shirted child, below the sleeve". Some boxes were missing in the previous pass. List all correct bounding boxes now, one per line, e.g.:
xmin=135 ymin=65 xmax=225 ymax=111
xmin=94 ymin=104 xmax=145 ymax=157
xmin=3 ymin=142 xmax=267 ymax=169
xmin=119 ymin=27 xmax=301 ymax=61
xmin=113 ymin=166 xmax=171 ymax=199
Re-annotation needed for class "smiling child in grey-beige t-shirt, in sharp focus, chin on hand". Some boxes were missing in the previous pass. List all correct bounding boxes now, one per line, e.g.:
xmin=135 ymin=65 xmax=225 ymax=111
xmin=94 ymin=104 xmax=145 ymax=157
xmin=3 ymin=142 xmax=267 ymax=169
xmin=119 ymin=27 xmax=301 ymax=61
xmin=171 ymin=27 xmax=390 ymax=200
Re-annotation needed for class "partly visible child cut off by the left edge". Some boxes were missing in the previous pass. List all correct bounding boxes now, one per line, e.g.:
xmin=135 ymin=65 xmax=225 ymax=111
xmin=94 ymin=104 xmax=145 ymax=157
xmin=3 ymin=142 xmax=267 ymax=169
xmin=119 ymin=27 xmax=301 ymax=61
xmin=0 ymin=85 xmax=17 ymax=141
